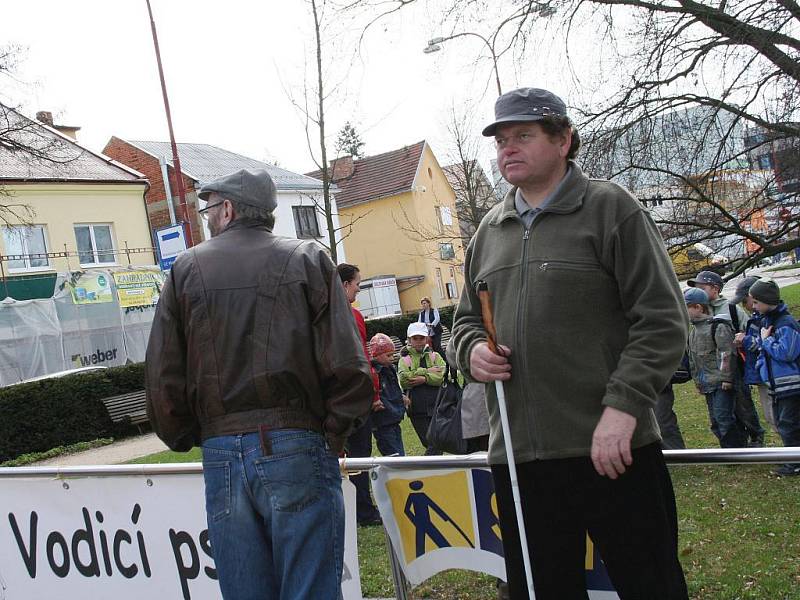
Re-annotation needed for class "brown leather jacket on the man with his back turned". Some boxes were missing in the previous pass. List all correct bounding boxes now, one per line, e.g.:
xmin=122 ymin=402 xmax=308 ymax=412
xmin=145 ymin=221 xmax=372 ymax=453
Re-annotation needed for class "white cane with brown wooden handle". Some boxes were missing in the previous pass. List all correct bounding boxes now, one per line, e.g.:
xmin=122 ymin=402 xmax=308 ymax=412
xmin=477 ymin=281 xmax=536 ymax=600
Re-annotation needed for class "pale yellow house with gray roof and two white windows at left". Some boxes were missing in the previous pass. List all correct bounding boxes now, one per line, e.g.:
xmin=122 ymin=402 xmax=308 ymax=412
xmin=0 ymin=106 xmax=156 ymax=299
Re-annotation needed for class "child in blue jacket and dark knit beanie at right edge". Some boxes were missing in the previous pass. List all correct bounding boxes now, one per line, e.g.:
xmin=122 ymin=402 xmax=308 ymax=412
xmin=742 ymin=279 xmax=800 ymax=476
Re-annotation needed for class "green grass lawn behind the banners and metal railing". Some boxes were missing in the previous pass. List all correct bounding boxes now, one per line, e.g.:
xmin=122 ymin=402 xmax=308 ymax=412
xmin=133 ymin=284 xmax=800 ymax=600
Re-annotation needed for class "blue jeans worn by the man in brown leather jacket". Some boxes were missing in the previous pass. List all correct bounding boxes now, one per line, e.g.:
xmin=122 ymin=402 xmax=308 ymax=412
xmin=203 ymin=429 xmax=344 ymax=600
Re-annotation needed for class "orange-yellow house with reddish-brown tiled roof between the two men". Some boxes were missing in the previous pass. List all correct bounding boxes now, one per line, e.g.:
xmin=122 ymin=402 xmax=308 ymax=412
xmin=310 ymin=141 xmax=464 ymax=312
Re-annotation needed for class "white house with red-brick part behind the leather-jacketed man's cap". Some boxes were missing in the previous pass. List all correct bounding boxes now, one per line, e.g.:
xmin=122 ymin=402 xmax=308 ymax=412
xmin=103 ymin=137 xmax=344 ymax=260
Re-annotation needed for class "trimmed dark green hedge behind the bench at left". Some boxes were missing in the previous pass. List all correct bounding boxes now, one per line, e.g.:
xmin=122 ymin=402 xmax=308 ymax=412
xmin=0 ymin=363 xmax=144 ymax=462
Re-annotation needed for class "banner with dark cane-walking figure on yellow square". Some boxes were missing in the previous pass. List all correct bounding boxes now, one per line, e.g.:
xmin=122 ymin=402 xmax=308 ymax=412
xmin=372 ymin=467 xmax=619 ymax=600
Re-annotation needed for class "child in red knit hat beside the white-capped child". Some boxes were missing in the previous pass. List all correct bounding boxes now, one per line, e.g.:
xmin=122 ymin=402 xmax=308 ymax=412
xmin=369 ymin=333 xmax=406 ymax=456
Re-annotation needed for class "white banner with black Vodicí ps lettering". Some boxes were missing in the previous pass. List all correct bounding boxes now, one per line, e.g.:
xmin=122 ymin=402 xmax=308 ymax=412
xmin=0 ymin=473 xmax=362 ymax=600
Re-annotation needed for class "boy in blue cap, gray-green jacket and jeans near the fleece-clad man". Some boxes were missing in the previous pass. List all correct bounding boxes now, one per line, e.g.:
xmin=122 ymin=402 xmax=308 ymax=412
xmin=684 ymin=288 xmax=747 ymax=448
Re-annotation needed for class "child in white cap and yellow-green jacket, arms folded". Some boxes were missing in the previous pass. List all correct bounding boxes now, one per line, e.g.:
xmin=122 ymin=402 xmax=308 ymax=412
xmin=397 ymin=322 xmax=446 ymax=456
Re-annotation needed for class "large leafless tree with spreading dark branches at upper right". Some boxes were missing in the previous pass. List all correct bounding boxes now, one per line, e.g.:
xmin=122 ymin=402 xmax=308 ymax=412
xmin=353 ymin=0 xmax=800 ymax=271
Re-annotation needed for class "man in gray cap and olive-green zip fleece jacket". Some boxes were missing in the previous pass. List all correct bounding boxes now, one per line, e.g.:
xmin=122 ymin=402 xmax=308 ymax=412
xmin=451 ymin=88 xmax=688 ymax=600
